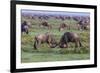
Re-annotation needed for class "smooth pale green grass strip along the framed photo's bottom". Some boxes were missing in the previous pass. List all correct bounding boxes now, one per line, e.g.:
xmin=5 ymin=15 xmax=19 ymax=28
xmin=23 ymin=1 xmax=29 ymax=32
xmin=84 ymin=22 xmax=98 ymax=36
xmin=21 ymin=52 xmax=89 ymax=63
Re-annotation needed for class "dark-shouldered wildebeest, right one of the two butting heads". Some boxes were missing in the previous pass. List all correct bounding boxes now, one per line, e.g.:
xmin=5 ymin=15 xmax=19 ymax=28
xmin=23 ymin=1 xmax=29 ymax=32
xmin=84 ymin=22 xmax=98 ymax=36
xmin=59 ymin=32 xmax=82 ymax=48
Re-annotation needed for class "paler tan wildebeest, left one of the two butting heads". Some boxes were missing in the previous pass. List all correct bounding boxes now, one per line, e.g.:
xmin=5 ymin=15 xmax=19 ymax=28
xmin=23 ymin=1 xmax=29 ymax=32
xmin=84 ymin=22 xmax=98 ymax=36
xmin=34 ymin=33 xmax=57 ymax=49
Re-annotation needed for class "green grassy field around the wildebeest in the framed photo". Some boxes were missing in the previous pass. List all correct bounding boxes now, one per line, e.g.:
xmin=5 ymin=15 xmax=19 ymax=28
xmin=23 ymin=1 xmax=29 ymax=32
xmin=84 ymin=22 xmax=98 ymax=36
xmin=21 ymin=18 xmax=90 ymax=63
